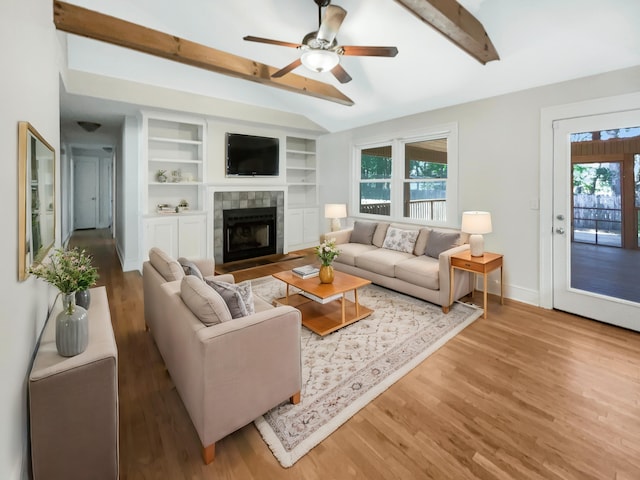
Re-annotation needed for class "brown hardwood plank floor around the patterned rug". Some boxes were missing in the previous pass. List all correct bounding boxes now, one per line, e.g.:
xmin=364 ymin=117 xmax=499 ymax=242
xmin=72 ymin=231 xmax=640 ymax=480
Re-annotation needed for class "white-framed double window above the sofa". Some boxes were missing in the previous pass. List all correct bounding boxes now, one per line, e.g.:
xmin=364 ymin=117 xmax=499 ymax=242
xmin=352 ymin=124 xmax=457 ymax=225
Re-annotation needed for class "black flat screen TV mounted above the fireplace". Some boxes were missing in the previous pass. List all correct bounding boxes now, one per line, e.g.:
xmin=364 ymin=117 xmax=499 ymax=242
xmin=227 ymin=133 xmax=280 ymax=177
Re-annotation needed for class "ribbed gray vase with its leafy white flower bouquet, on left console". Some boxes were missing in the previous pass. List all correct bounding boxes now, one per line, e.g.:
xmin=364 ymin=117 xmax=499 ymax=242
xmin=29 ymin=248 xmax=98 ymax=357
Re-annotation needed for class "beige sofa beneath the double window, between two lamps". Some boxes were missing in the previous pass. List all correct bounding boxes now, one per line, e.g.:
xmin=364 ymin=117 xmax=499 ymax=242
xmin=321 ymin=221 xmax=471 ymax=313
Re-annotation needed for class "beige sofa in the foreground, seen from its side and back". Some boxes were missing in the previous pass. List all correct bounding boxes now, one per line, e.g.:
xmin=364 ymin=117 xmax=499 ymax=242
xmin=142 ymin=249 xmax=301 ymax=463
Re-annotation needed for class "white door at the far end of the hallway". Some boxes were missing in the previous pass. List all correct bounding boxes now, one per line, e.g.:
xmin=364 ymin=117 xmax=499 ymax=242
xmin=73 ymin=157 xmax=98 ymax=229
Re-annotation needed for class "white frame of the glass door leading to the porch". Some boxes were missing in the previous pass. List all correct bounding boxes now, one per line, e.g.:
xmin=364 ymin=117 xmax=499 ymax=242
xmin=553 ymin=111 xmax=640 ymax=331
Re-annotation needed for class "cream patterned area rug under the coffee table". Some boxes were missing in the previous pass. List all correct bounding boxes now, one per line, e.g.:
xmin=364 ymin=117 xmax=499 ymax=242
xmin=252 ymin=278 xmax=482 ymax=467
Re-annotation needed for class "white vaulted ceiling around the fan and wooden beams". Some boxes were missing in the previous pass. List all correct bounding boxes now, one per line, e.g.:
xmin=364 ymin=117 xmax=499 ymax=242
xmin=61 ymin=0 xmax=640 ymax=141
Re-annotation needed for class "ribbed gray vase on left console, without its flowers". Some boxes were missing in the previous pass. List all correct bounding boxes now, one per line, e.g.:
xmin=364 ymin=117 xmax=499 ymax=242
xmin=56 ymin=293 xmax=89 ymax=357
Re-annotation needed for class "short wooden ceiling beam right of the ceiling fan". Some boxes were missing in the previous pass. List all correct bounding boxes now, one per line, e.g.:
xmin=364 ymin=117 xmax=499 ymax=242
xmin=396 ymin=0 xmax=500 ymax=65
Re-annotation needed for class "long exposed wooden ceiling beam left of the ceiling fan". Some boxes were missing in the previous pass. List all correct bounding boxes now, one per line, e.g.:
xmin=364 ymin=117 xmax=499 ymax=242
xmin=53 ymin=1 xmax=353 ymax=106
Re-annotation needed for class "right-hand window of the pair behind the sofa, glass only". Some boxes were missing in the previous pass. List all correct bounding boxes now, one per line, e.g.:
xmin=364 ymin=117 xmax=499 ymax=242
xmin=403 ymin=138 xmax=447 ymax=221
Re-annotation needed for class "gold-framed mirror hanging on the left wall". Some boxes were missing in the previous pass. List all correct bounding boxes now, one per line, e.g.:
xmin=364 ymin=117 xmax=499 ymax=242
xmin=18 ymin=122 xmax=56 ymax=280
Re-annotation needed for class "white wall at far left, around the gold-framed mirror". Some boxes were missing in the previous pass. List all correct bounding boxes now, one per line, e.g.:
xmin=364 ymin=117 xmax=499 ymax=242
xmin=0 ymin=0 xmax=60 ymax=480
